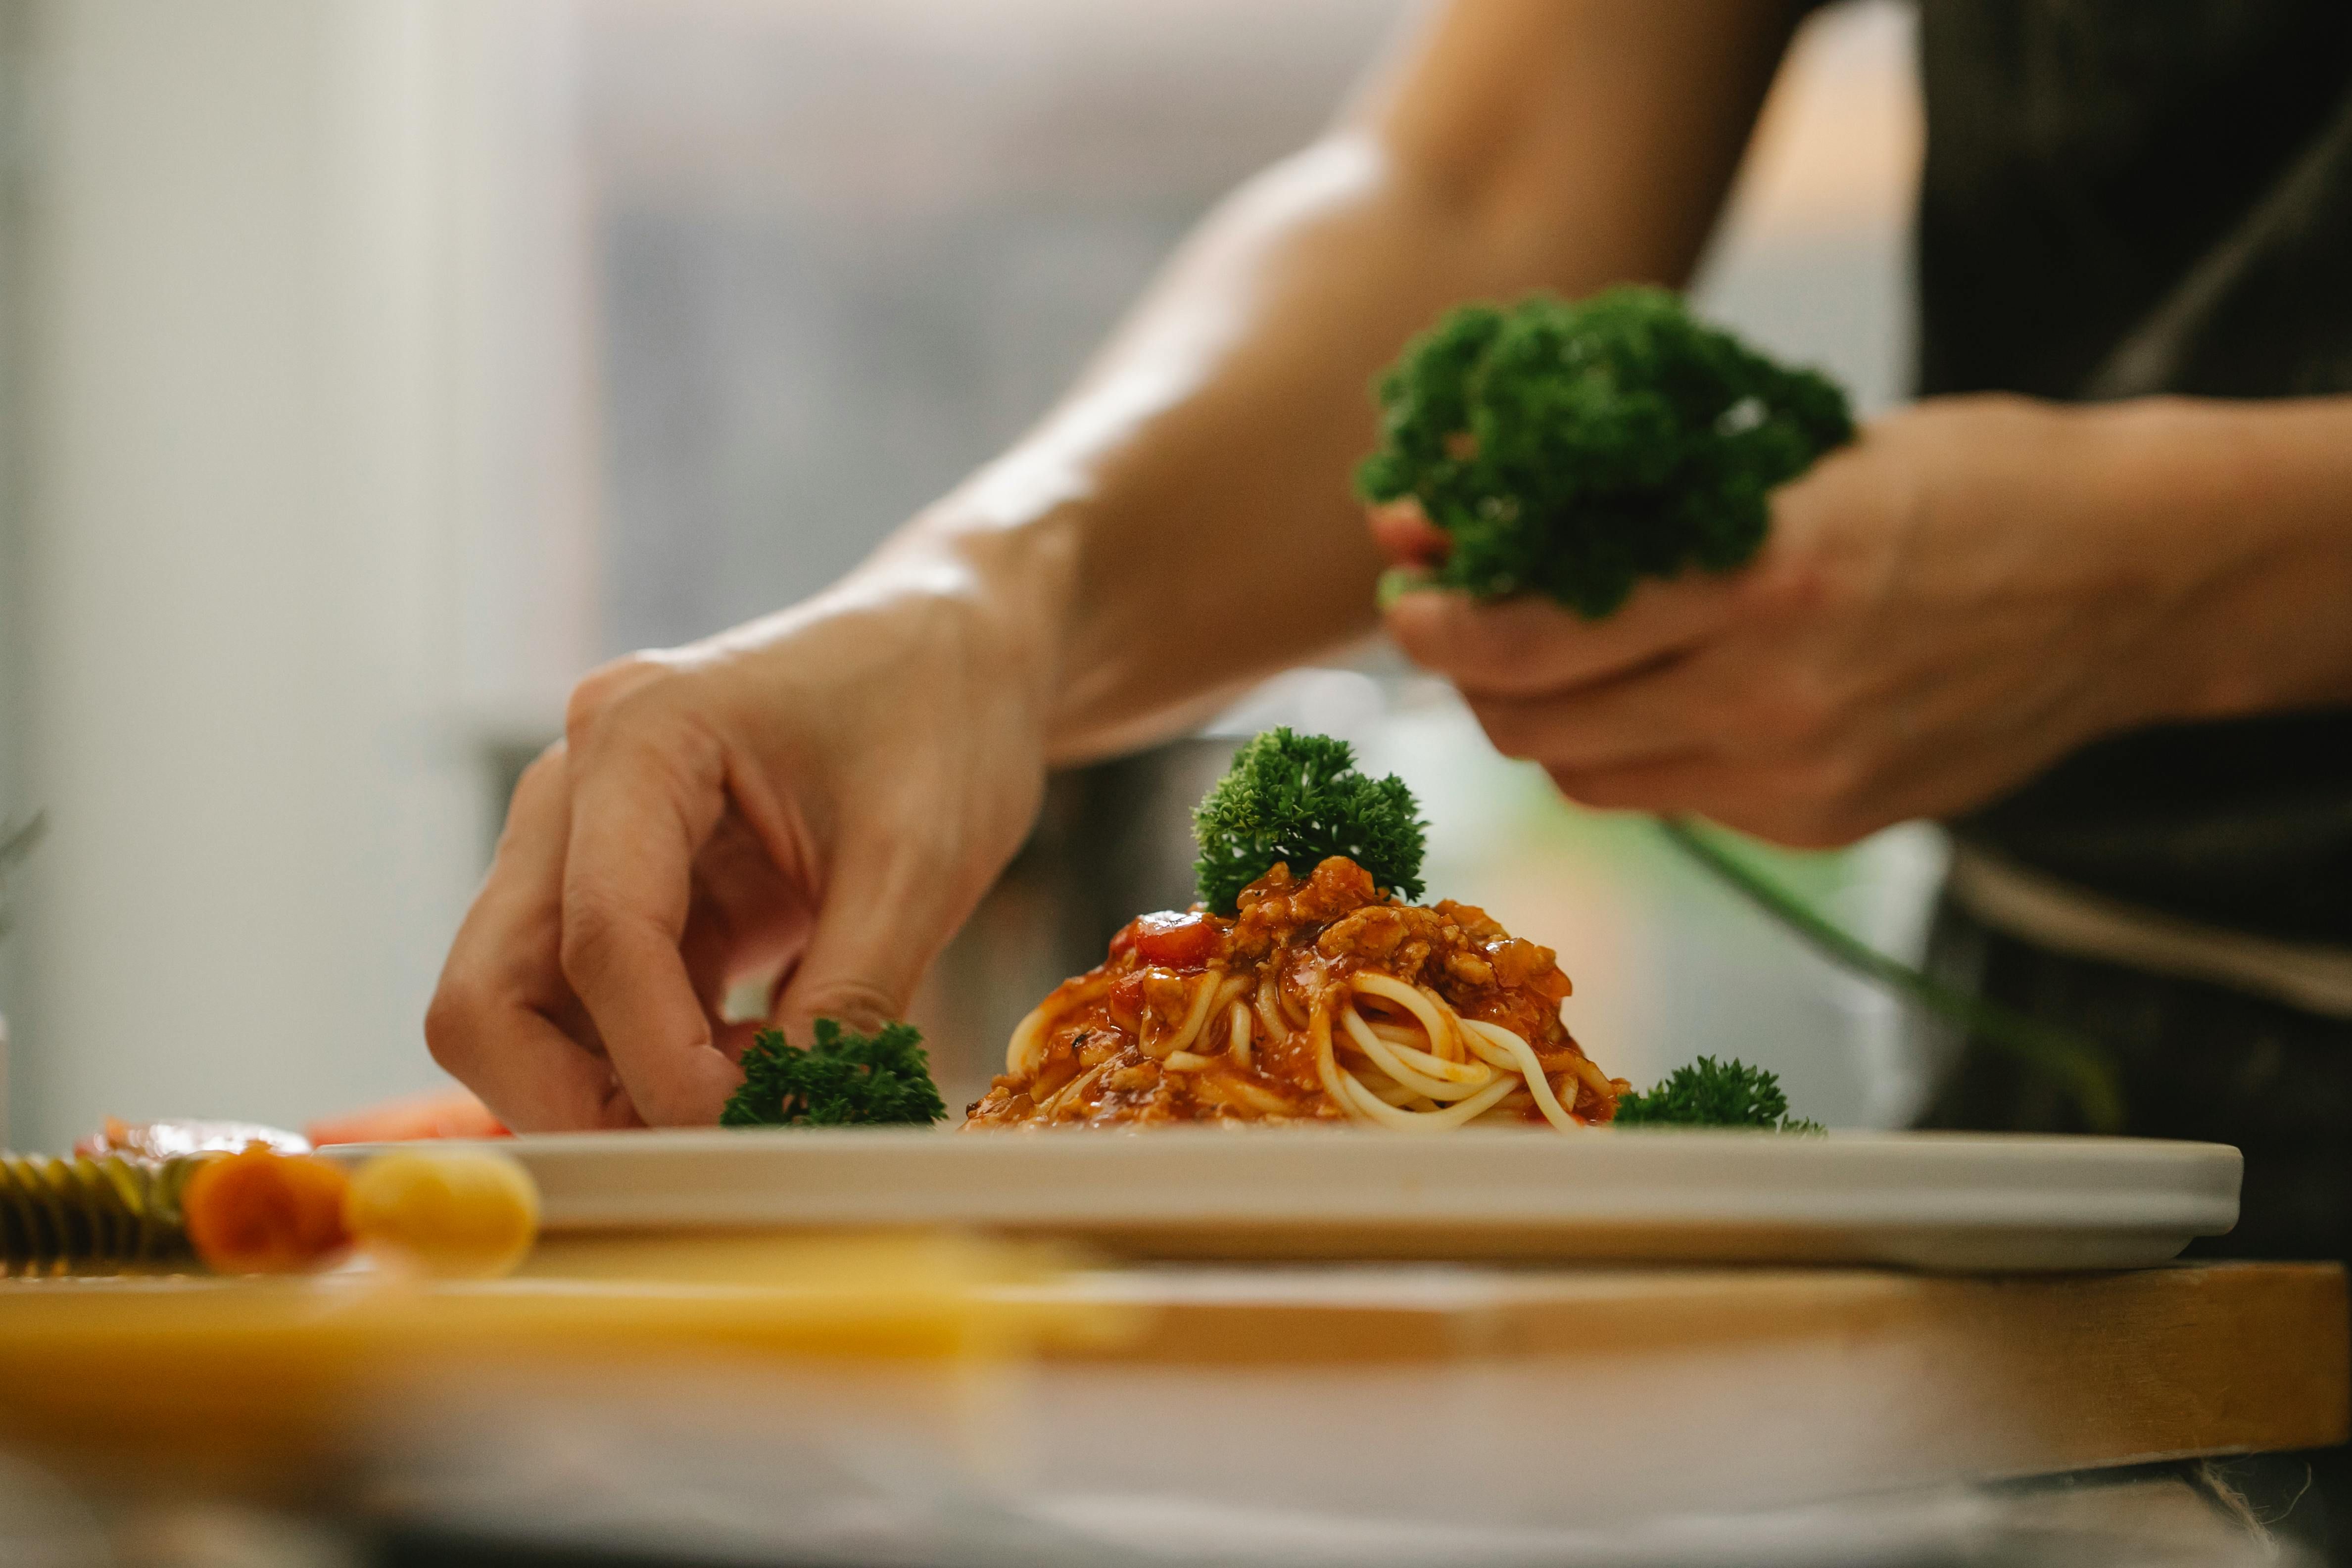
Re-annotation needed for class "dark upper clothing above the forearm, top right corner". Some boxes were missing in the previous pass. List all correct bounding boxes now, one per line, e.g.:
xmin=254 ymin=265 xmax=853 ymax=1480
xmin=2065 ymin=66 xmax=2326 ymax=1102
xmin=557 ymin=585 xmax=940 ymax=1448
xmin=1919 ymin=0 xmax=2352 ymax=397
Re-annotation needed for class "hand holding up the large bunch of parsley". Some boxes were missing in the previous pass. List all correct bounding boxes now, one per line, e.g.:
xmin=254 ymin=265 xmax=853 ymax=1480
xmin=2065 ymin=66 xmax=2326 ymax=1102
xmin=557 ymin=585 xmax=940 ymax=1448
xmin=1371 ymin=397 xmax=2223 ymax=846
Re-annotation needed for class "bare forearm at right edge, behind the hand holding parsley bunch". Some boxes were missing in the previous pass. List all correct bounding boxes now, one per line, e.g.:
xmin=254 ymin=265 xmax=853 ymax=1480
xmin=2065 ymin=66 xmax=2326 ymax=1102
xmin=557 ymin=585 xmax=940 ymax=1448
xmin=2079 ymin=397 xmax=2352 ymax=722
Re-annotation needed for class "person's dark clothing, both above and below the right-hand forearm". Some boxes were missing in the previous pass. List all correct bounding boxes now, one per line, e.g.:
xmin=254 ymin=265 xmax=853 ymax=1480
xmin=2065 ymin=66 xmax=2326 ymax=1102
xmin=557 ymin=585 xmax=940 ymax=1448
xmin=1919 ymin=0 xmax=2352 ymax=1563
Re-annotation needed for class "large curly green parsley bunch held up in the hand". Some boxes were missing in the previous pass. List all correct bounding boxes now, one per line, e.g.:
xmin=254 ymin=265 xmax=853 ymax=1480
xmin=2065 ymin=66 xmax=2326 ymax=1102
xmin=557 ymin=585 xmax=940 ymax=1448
xmin=1357 ymin=287 xmax=1853 ymax=620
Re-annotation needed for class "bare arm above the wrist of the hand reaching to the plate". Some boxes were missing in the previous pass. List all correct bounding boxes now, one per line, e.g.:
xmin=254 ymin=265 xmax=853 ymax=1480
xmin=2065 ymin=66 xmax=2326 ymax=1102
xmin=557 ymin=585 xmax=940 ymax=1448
xmin=875 ymin=0 xmax=1795 ymax=757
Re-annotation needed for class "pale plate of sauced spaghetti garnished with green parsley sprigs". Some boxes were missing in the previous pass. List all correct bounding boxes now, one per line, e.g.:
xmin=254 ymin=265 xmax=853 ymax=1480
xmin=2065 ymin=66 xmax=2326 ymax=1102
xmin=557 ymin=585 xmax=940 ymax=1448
xmin=336 ymin=731 xmax=2242 ymax=1270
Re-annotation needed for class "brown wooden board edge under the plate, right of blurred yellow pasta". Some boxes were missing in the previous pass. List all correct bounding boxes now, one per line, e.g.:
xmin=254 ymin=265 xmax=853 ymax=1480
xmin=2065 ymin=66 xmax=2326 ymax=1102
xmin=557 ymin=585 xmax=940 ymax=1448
xmin=1049 ymin=1262 xmax=2352 ymax=1474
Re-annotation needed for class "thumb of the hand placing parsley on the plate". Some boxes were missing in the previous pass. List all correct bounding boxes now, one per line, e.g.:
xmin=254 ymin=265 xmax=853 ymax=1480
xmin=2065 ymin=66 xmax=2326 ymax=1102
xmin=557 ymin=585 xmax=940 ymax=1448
xmin=774 ymin=846 xmax=969 ymax=1042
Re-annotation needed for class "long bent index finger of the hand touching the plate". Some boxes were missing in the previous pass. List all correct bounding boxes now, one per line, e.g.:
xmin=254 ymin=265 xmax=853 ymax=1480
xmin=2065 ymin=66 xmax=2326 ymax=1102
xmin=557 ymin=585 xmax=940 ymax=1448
xmin=562 ymin=717 xmax=741 ymax=1126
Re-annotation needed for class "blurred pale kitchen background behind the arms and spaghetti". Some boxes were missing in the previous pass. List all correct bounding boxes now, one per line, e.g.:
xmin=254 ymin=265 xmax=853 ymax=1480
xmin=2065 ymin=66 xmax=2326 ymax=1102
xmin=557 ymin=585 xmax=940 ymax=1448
xmin=0 ymin=0 xmax=1940 ymax=1147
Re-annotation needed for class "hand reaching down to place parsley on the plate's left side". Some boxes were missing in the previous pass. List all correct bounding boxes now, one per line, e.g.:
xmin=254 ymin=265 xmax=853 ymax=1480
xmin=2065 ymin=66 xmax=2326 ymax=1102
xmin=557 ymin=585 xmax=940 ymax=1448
xmin=426 ymin=581 xmax=1044 ymax=1131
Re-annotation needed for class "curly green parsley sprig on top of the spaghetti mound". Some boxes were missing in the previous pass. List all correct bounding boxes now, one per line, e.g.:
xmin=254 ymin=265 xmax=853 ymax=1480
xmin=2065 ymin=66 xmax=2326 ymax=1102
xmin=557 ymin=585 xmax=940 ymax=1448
xmin=1193 ymin=729 xmax=1428 ymax=914
